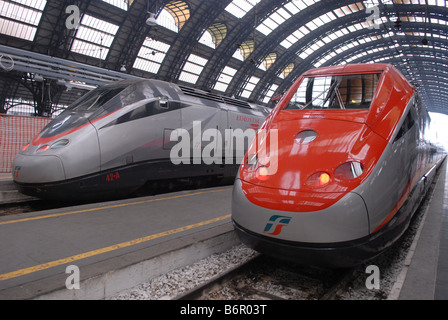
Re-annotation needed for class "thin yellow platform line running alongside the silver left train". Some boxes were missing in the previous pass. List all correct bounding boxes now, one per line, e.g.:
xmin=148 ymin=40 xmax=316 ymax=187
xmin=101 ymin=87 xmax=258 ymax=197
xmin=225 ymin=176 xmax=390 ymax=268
xmin=0 ymin=189 xmax=229 ymax=226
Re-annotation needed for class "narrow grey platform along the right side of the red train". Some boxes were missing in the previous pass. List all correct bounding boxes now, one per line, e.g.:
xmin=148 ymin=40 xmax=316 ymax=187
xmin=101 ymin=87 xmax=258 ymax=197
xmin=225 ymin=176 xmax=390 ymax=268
xmin=389 ymin=160 xmax=448 ymax=300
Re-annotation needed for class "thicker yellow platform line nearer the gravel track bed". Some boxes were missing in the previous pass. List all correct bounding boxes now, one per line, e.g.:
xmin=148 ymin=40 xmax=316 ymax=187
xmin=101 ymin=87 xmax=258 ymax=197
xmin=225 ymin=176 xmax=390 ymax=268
xmin=0 ymin=214 xmax=231 ymax=281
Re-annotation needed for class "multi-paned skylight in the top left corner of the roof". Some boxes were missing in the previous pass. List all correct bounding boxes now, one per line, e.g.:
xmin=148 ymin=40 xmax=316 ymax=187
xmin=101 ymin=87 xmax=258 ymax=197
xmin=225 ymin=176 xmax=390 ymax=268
xmin=0 ymin=0 xmax=47 ymax=41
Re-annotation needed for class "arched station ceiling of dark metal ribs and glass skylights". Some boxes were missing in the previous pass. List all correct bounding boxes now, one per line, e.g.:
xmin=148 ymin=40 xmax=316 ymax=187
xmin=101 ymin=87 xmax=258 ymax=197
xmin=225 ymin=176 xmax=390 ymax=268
xmin=0 ymin=0 xmax=448 ymax=114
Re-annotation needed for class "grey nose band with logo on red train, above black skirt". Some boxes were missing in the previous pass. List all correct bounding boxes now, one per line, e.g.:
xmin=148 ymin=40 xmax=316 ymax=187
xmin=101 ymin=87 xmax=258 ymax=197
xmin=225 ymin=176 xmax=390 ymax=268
xmin=232 ymin=179 xmax=369 ymax=243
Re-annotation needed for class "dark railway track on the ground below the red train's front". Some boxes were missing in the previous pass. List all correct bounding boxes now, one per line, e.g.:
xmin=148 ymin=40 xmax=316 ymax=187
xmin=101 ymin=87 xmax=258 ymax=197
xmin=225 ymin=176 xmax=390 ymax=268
xmin=175 ymin=255 xmax=357 ymax=300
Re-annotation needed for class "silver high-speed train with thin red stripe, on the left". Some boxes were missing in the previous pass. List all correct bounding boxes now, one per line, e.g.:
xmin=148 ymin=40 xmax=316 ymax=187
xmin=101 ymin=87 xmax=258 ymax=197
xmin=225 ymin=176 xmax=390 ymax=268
xmin=12 ymin=80 xmax=270 ymax=200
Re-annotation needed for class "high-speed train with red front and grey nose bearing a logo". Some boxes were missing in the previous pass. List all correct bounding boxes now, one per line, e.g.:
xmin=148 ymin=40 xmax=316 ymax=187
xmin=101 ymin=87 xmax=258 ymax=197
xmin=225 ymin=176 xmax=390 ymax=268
xmin=232 ymin=64 xmax=445 ymax=267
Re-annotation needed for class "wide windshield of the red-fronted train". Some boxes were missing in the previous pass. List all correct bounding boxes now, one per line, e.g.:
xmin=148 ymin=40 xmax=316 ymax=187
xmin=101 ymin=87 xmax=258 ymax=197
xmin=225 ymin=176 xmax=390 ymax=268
xmin=285 ymin=73 xmax=381 ymax=110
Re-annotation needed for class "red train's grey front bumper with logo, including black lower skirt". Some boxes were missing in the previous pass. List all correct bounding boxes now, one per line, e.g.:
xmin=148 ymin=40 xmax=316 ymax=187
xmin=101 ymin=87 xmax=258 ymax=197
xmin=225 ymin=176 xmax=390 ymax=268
xmin=232 ymin=179 xmax=378 ymax=267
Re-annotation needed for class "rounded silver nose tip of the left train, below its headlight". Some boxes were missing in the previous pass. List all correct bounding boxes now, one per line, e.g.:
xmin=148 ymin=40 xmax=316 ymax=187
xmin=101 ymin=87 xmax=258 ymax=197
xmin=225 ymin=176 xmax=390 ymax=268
xmin=12 ymin=154 xmax=65 ymax=184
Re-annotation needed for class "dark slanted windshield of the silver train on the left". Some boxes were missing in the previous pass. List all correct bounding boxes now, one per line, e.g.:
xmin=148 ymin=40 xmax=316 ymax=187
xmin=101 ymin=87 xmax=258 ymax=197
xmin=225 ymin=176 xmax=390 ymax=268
xmin=67 ymin=86 xmax=127 ymax=112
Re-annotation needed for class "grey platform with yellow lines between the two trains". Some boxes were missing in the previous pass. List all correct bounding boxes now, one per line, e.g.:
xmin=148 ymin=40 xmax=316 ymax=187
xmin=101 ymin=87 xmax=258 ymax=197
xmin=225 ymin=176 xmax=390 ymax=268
xmin=0 ymin=186 xmax=239 ymax=300
